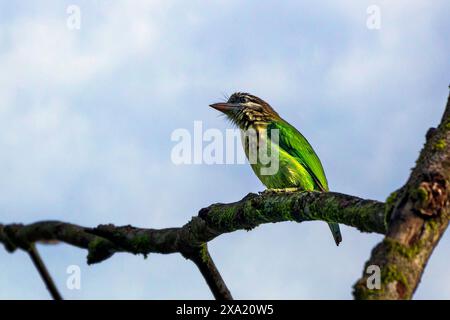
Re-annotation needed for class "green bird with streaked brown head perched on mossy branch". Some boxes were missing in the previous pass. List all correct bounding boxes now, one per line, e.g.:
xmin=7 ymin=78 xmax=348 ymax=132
xmin=210 ymin=92 xmax=342 ymax=245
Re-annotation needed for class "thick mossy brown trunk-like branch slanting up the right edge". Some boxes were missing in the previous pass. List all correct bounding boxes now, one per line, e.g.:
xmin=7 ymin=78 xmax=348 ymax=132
xmin=354 ymin=92 xmax=450 ymax=299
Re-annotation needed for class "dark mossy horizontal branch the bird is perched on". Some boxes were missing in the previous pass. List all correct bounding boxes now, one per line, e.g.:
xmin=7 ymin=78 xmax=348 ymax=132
xmin=0 ymin=190 xmax=386 ymax=299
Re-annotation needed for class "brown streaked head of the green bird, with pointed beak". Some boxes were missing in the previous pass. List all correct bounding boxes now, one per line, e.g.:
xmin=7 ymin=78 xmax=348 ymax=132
xmin=210 ymin=92 xmax=279 ymax=130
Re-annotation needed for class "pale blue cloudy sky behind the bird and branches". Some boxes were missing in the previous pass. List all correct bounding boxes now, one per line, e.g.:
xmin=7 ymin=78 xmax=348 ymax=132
xmin=0 ymin=0 xmax=450 ymax=299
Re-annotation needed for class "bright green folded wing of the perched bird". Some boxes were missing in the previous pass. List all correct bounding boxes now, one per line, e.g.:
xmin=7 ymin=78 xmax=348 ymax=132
xmin=267 ymin=120 xmax=328 ymax=191
